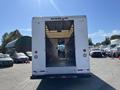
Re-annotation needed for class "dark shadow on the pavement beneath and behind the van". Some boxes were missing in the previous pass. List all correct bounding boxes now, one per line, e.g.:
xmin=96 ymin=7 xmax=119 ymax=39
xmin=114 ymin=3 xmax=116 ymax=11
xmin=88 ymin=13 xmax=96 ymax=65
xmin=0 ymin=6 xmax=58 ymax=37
xmin=37 ymin=74 xmax=116 ymax=90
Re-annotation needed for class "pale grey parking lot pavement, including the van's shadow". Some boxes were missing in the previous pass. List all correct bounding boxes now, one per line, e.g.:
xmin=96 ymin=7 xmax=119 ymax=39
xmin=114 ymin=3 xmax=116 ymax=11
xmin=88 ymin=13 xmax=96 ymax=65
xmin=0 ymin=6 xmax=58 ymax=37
xmin=0 ymin=58 xmax=120 ymax=90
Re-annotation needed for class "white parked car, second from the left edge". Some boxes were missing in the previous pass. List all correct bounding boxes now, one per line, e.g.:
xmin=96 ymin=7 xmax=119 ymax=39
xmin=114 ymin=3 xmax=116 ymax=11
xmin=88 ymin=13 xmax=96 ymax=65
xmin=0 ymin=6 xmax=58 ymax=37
xmin=14 ymin=53 xmax=29 ymax=63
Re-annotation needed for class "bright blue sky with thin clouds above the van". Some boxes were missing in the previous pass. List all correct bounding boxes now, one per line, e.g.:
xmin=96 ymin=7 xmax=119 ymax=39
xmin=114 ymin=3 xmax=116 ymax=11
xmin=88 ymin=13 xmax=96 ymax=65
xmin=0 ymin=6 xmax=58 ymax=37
xmin=0 ymin=0 xmax=120 ymax=43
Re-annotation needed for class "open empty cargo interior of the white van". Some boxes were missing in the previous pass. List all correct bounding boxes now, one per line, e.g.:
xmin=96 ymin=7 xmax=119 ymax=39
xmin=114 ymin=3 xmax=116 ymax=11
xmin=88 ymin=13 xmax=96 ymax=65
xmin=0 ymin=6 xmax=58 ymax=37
xmin=45 ymin=20 xmax=76 ymax=67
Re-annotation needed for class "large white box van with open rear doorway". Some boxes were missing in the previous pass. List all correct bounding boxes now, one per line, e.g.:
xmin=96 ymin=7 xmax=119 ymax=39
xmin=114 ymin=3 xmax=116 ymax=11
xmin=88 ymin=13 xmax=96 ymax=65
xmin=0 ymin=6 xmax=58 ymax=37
xmin=31 ymin=16 xmax=90 ymax=79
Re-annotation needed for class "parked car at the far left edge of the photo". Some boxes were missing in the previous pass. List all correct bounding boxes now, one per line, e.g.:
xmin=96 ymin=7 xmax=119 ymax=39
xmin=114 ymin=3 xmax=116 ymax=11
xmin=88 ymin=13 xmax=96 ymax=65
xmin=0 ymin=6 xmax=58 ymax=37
xmin=0 ymin=53 xmax=13 ymax=67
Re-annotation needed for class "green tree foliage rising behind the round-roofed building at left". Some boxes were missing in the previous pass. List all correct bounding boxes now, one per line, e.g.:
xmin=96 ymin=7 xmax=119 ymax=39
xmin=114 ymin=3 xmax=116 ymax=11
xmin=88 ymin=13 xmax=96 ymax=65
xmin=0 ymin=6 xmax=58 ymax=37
xmin=1 ymin=29 xmax=22 ymax=53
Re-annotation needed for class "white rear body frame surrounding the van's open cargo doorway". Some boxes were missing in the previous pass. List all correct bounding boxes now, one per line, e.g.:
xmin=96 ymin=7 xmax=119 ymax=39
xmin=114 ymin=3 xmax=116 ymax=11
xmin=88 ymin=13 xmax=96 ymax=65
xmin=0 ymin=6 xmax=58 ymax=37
xmin=32 ymin=16 xmax=90 ymax=75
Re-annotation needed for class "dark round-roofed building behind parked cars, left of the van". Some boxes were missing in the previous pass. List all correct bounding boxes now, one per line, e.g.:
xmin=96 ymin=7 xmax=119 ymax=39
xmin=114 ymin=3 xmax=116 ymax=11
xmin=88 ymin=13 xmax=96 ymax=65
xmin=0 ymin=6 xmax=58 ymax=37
xmin=6 ymin=36 xmax=32 ymax=53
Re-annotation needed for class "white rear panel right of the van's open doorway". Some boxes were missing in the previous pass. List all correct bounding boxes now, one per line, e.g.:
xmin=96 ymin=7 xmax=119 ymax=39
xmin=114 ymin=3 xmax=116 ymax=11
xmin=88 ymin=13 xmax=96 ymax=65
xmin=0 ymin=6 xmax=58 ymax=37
xmin=74 ymin=16 xmax=90 ymax=73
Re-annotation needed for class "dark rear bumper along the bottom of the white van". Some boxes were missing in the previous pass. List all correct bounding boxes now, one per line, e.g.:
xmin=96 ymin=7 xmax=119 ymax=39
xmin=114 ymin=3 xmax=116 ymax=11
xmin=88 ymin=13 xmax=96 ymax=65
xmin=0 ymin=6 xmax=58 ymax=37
xmin=30 ymin=73 xmax=91 ymax=79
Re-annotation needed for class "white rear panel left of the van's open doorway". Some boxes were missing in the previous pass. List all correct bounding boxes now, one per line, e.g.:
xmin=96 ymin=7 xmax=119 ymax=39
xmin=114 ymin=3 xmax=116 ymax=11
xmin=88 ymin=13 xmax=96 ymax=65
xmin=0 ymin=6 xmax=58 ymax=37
xmin=32 ymin=17 xmax=46 ymax=75
